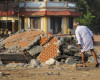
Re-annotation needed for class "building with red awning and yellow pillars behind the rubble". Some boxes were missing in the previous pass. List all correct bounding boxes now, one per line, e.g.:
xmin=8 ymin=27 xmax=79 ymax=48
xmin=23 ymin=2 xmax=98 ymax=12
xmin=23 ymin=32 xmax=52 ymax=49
xmin=0 ymin=0 xmax=81 ymax=34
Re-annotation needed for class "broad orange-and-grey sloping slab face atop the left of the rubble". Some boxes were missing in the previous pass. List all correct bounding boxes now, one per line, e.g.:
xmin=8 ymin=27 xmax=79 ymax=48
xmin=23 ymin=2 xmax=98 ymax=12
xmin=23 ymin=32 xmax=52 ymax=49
xmin=3 ymin=30 xmax=44 ymax=48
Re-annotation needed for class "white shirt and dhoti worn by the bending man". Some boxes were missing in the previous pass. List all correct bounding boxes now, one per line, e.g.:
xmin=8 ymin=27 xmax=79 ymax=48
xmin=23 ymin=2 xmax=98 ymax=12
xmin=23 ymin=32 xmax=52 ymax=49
xmin=75 ymin=26 xmax=94 ymax=52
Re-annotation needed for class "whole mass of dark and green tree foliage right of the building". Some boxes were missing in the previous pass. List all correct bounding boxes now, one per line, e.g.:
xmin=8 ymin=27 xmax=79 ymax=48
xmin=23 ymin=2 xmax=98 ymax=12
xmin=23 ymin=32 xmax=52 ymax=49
xmin=67 ymin=0 xmax=100 ymax=34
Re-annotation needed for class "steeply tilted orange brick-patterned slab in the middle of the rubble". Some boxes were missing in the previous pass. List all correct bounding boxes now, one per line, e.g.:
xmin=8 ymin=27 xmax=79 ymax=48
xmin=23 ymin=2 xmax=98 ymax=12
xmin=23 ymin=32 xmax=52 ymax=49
xmin=38 ymin=37 xmax=60 ymax=63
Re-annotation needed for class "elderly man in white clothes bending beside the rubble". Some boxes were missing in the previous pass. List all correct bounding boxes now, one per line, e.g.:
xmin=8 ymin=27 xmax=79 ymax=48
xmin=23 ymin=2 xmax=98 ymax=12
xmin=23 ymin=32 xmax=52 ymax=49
xmin=73 ymin=21 xmax=99 ymax=67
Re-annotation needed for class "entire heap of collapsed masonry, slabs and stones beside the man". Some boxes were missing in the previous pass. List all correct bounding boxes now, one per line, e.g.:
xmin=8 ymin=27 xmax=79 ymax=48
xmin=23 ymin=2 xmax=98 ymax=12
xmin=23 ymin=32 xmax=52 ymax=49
xmin=0 ymin=29 xmax=100 ymax=68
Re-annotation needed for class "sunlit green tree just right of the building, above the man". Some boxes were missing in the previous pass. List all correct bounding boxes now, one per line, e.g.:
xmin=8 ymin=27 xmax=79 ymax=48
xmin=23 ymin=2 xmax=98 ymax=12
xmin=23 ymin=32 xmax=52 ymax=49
xmin=77 ymin=0 xmax=95 ymax=28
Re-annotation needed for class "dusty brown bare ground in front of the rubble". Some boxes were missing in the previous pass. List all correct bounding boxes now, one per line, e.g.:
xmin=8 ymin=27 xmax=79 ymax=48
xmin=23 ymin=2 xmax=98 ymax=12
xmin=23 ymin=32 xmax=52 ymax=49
xmin=0 ymin=37 xmax=100 ymax=80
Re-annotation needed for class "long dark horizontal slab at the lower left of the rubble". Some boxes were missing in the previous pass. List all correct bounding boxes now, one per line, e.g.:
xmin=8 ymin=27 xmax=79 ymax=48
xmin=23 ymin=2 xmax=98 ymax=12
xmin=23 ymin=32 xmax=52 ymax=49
xmin=0 ymin=53 xmax=32 ymax=64
